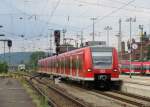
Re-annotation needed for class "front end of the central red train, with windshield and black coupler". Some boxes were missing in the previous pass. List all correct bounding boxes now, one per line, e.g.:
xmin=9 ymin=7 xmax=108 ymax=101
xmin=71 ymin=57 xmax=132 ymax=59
xmin=91 ymin=47 xmax=119 ymax=86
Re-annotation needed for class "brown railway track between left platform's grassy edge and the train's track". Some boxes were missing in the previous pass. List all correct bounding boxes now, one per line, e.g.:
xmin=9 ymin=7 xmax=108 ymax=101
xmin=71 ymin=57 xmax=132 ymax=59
xmin=15 ymin=74 xmax=90 ymax=107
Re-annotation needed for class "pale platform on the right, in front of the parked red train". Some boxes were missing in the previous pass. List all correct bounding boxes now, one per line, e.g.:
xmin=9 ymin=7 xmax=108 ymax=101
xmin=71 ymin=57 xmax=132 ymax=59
xmin=120 ymin=75 xmax=150 ymax=97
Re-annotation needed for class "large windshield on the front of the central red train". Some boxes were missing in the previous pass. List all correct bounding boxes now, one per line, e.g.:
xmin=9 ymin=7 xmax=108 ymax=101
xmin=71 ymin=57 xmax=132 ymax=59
xmin=92 ymin=49 xmax=112 ymax=68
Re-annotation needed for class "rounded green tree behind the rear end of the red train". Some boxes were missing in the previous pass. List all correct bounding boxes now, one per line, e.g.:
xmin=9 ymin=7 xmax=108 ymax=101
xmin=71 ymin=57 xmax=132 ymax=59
xmin=28 ymin=52 xmax=45 ymax=69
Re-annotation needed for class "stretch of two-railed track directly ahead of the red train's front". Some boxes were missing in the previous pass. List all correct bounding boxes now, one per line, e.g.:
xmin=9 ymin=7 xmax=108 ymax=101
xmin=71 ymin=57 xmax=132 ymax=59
xmin=93 ymin=90 xmax=150 ymax=107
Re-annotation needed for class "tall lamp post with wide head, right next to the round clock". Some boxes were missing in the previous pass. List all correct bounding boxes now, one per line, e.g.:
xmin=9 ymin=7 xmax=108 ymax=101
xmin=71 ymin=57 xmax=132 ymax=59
xmin=126 ymin=17 xmax=136 ymax=78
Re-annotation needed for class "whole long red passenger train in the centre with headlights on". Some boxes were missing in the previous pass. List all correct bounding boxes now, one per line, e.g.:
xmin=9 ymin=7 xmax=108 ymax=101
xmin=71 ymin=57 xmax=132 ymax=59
xmin=38 ymin=47 xmax=119 ymax=87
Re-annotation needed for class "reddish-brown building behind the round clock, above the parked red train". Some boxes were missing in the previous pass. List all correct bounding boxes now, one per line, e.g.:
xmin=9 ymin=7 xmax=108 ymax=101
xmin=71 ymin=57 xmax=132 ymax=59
xmin=119 ymin=35 xmax=150 ymax=61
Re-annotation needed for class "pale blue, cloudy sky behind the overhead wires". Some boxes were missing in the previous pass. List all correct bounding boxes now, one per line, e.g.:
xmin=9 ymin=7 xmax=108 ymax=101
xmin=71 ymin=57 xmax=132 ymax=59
xmin=0 ymin=0 xmax=150 ymax=53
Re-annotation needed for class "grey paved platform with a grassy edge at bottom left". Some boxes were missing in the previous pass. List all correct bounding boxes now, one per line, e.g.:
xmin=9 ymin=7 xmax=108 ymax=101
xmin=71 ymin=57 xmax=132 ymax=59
xmin=0 ymin=78 xmax=36 ymax=107
